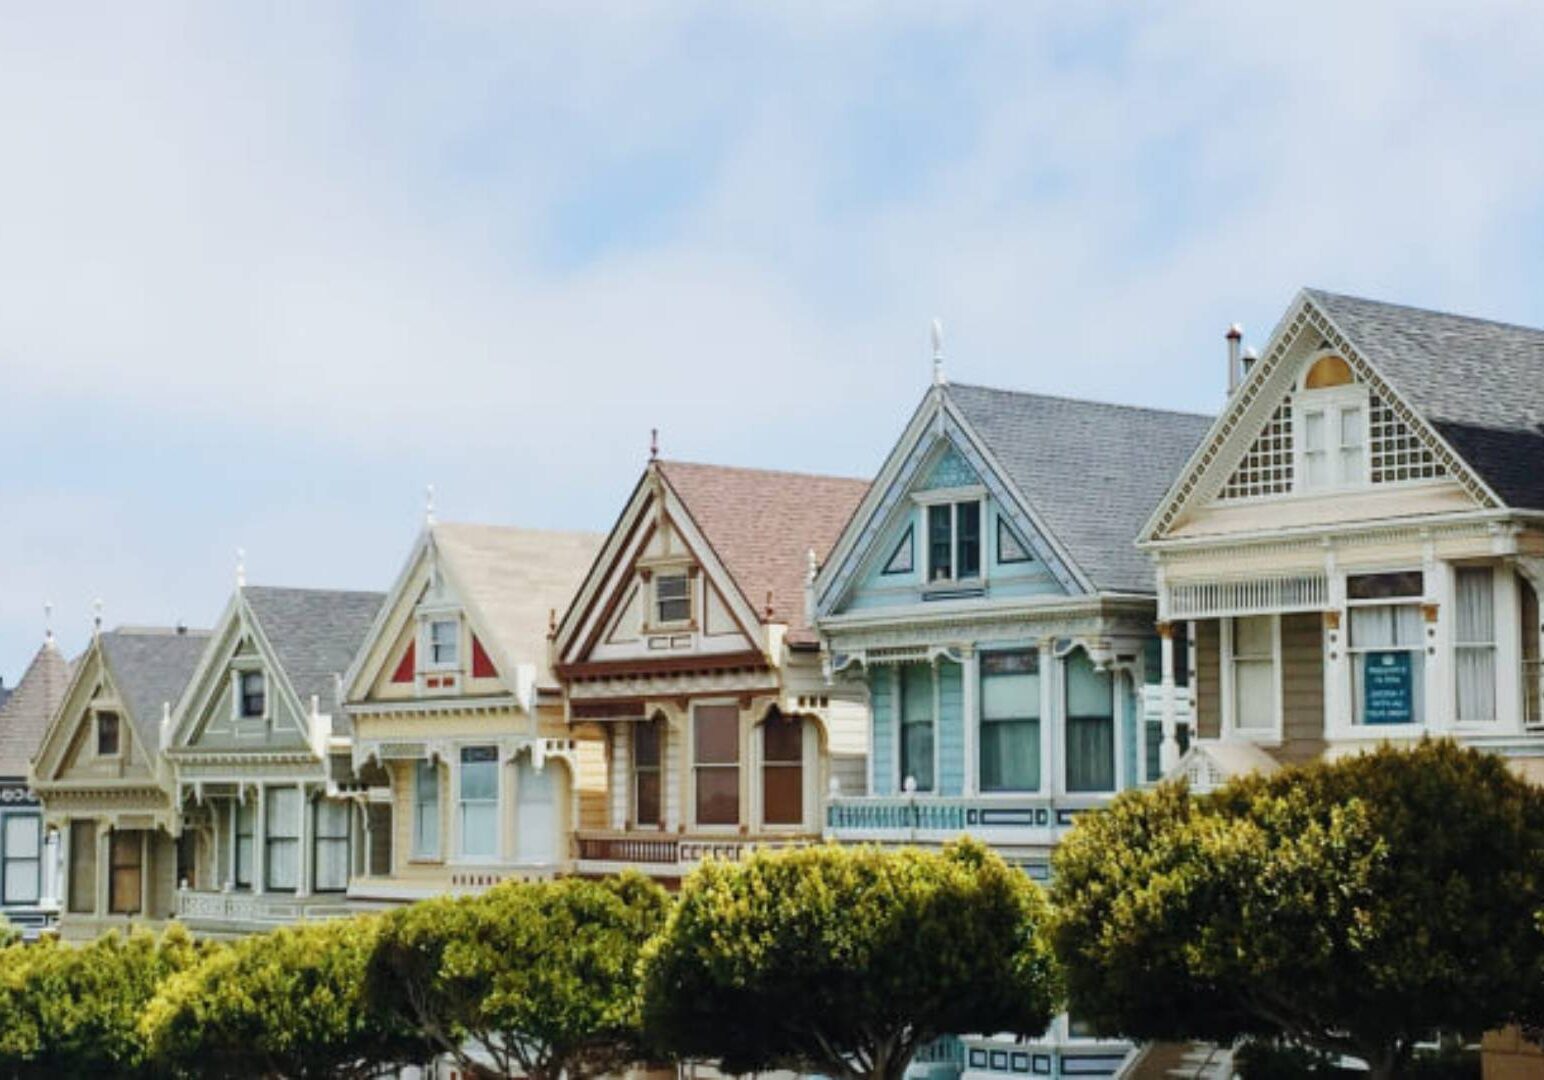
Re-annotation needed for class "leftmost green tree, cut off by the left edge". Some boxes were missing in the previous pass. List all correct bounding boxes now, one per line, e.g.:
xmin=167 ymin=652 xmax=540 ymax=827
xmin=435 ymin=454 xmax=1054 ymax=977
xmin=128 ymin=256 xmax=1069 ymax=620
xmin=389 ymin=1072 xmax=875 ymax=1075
xmin=0 ymin=927 xmax=208 ymax=1077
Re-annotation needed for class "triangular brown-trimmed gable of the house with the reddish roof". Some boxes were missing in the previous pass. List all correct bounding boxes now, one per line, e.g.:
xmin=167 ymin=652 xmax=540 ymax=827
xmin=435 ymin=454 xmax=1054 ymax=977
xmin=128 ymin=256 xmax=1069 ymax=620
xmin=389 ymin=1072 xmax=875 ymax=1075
xmin=554 ymin=464 xmax=769 ymax=675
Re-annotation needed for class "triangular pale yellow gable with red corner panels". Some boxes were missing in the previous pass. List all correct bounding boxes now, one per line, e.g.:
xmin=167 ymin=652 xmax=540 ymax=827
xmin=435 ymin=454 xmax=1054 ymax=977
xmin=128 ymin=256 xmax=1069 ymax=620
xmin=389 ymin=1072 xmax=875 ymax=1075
xmin=343 ymin=528 xmax=518 ymax=703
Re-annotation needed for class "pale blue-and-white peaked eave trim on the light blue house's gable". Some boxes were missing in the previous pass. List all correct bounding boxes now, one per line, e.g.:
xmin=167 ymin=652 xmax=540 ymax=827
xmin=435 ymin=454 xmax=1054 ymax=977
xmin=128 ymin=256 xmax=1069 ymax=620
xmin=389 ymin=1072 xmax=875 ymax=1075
xmin=815 ymin=385 xmax=1096 ymax=618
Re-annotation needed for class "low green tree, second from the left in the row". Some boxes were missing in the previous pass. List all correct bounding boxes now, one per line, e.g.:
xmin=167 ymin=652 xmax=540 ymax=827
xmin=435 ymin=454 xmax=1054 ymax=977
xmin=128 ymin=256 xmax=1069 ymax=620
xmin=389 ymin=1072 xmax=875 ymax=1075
xmin=142 ymin=916 xmax=431 ymax=1078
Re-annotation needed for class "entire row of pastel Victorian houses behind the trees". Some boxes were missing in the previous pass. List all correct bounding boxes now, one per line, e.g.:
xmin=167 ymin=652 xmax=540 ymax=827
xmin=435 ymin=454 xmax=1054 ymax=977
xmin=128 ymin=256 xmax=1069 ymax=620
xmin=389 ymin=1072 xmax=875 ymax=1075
xmin=0 ymin=290 xmax=1544 ymax=1075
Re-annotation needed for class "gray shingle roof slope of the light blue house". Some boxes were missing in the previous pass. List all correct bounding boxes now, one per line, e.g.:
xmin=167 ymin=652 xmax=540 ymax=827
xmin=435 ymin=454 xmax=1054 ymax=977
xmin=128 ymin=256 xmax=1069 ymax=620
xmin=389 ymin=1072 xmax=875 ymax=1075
xmin=948 ymin=383 xmax=1212 ymax=593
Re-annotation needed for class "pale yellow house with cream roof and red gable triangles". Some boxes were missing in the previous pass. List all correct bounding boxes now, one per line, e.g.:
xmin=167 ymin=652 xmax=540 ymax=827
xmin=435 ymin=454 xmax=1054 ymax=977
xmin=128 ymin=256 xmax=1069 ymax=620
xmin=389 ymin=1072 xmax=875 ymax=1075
xmin=344 ymin=524 xmax=605 ymax=905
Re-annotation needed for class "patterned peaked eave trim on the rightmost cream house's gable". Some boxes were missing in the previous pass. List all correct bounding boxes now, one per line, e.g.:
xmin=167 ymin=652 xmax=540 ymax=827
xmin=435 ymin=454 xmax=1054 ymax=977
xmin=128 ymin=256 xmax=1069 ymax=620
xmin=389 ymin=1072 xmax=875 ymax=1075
xmin=1138 ymin=289 xmax=1504 ymax=547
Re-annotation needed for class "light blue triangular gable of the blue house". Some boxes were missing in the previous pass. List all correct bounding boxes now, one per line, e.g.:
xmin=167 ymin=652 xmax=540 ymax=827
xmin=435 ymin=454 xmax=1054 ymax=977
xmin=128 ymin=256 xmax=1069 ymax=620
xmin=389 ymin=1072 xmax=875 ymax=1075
xmin=815 ymin=388 xmax=1092 ymax=616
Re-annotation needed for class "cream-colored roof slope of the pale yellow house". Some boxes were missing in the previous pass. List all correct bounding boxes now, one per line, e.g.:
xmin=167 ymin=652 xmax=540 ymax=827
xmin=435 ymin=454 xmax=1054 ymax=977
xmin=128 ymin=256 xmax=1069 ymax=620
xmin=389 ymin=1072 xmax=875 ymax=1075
xmin=429 ymin=524 xmax=605 ymax=684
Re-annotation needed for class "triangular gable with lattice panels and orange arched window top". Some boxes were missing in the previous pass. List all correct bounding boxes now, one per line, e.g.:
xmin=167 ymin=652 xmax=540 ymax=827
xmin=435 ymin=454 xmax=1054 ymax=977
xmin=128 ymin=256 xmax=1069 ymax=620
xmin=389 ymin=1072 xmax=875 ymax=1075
xmin=1143 ymin=292 xmax=1499 ymax=541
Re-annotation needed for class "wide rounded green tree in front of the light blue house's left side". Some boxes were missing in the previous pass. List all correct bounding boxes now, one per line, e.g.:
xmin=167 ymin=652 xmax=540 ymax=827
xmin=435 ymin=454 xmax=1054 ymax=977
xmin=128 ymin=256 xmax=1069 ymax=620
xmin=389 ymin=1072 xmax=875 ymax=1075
xmin=644 ymin=841 xmax=1059 ymax=1080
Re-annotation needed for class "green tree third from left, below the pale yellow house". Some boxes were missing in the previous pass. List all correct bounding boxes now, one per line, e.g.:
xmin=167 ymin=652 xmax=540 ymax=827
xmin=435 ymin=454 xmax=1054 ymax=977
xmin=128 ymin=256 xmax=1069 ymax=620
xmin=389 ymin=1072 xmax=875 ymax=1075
xmin=369 ymin=873 xmax=670 ymax=1080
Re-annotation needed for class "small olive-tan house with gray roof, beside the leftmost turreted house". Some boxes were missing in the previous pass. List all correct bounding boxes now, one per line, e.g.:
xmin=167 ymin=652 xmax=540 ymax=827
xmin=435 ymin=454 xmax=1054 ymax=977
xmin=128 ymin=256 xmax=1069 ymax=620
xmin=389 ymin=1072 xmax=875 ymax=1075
xmin=31 ymin=626 xmax=208 ymax=939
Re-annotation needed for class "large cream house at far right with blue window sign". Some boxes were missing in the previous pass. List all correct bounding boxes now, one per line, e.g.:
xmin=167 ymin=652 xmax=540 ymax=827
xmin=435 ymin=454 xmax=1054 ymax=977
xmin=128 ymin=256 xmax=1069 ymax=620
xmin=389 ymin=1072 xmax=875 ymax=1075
xmin=1141 ymin=290 xmax=1544 ymax=786
